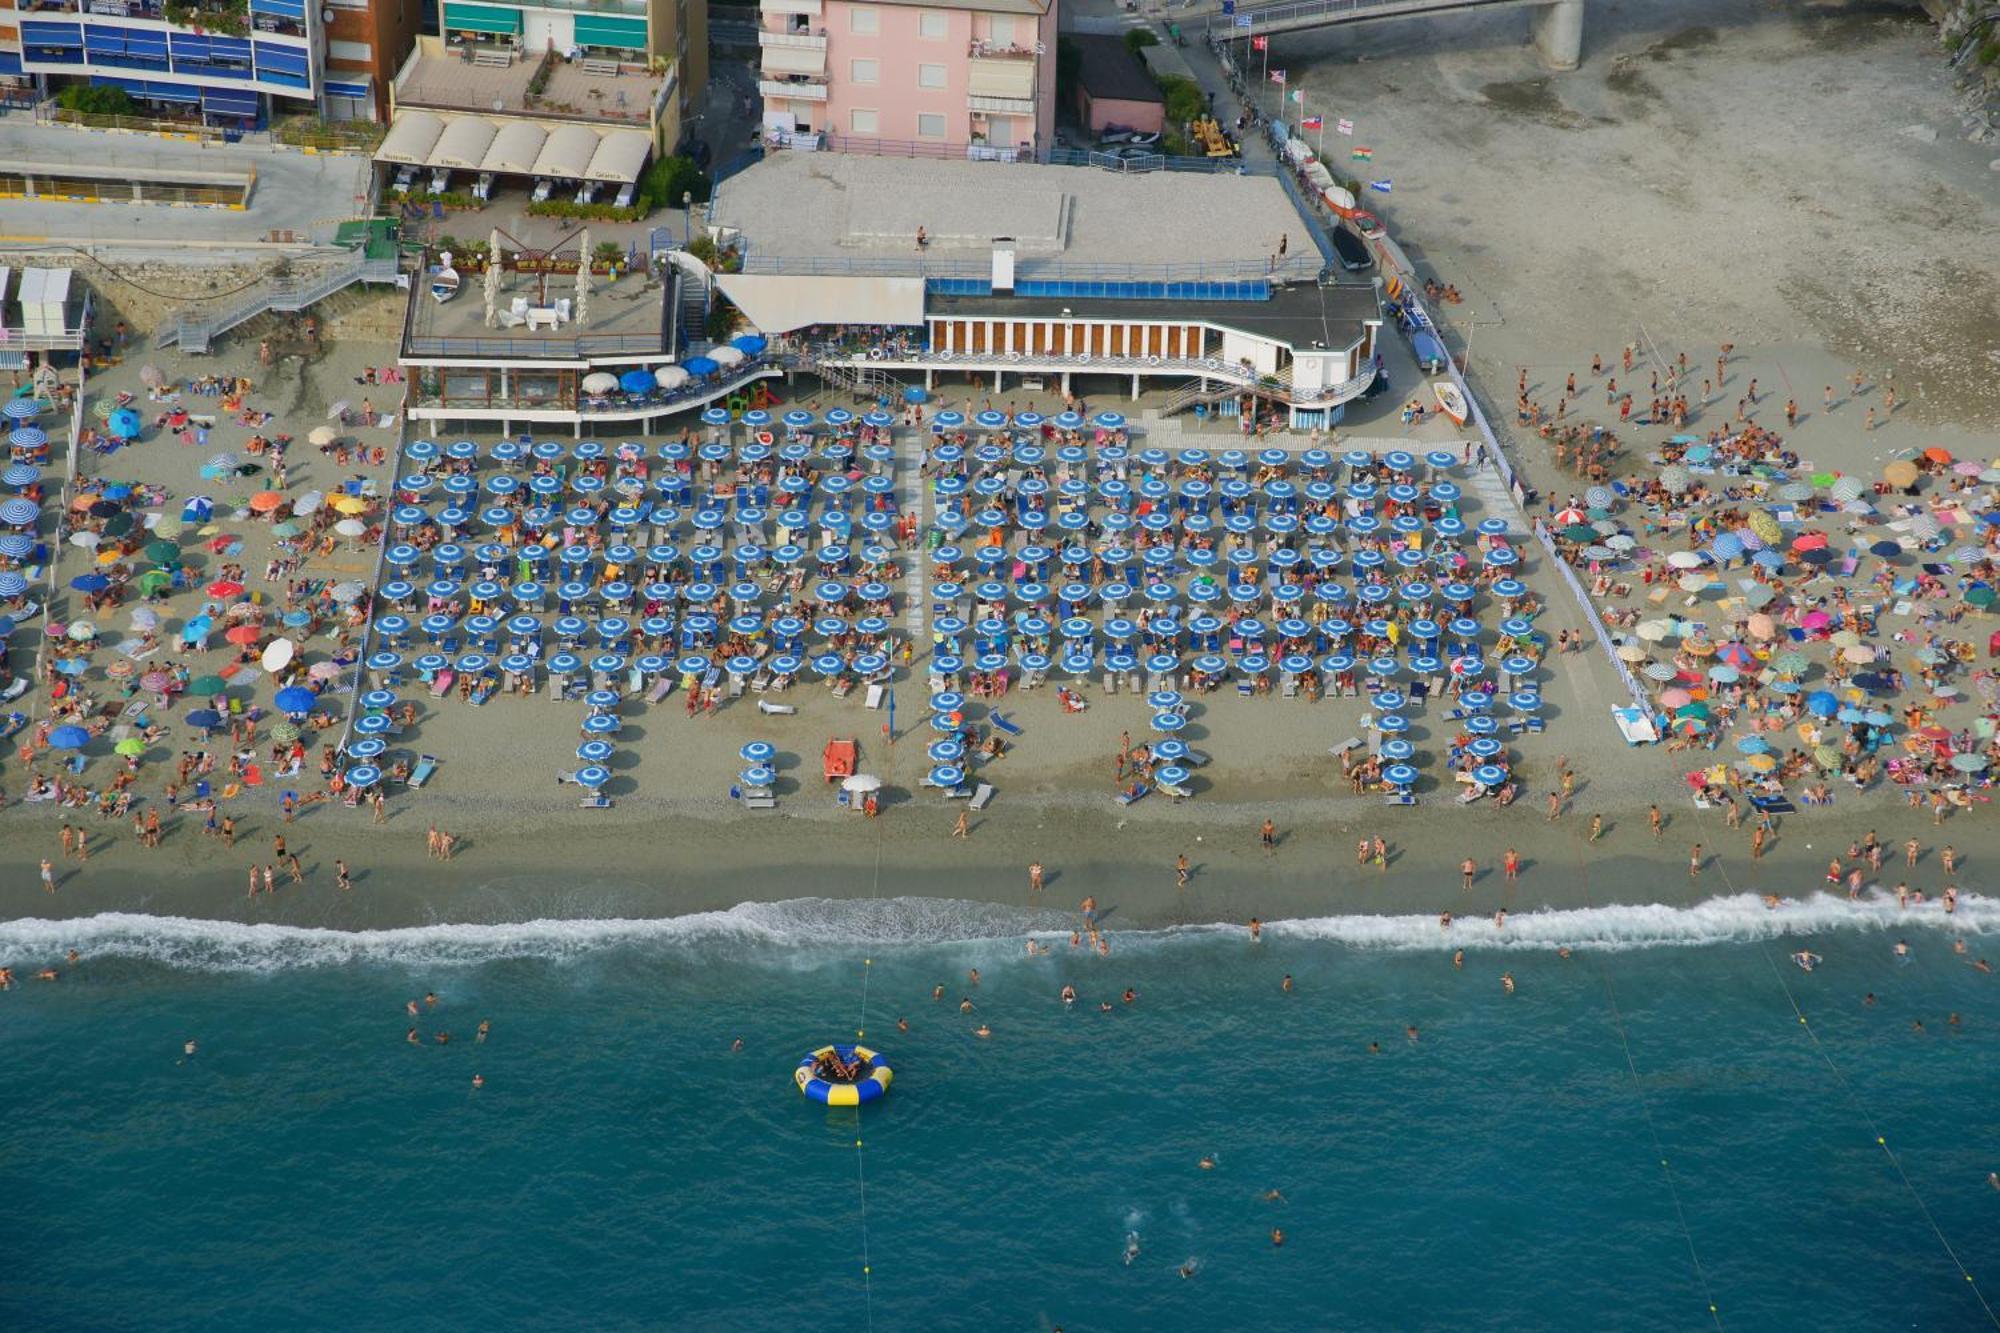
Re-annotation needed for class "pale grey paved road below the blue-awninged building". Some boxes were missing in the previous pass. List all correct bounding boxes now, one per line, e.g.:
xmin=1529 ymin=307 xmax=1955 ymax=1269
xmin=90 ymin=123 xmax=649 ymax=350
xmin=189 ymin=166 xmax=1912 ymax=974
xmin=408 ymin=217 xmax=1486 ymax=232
xmin=0 ymin=114 xmax=368 ymax=246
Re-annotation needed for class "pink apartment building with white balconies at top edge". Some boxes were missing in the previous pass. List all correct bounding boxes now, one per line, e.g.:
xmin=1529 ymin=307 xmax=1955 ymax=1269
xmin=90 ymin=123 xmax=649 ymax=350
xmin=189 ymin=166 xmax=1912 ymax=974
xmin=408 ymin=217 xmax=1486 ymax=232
xmin=758 ymin=0 xmax=1056 ymax=158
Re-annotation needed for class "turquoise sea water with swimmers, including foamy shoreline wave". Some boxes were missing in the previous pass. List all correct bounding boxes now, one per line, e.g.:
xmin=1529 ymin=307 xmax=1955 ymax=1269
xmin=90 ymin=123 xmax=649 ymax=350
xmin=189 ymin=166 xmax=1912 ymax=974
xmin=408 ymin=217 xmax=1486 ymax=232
xmin=0 ymin=899 xmax=2000 ymax=1331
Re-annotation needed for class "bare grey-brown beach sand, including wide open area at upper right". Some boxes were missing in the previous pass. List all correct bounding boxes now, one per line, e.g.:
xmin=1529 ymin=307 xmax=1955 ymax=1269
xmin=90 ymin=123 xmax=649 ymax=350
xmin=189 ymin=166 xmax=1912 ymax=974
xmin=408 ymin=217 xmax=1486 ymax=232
xmin=0 ymin=4 xmax=2000 ymax=927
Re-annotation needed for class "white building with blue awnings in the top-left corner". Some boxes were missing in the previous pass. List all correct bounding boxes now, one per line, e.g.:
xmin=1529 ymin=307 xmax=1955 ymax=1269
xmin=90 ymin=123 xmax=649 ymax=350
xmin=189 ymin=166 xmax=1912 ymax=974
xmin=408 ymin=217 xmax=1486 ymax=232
xmin=0 ymin=0 xmax=322 ymax=128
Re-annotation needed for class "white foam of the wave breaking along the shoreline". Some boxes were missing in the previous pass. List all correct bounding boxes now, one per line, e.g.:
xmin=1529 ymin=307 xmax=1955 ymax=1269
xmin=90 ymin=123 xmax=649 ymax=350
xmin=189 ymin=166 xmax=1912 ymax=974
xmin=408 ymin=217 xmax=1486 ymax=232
xmin=0 ymin=893 xmax=2000 ymax=973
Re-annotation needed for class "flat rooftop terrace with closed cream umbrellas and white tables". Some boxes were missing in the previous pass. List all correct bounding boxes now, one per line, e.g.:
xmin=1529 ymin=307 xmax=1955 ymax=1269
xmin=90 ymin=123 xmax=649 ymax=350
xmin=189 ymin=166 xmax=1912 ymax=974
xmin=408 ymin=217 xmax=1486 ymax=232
xmin=404 ymin=262 xmax=670 ymax=358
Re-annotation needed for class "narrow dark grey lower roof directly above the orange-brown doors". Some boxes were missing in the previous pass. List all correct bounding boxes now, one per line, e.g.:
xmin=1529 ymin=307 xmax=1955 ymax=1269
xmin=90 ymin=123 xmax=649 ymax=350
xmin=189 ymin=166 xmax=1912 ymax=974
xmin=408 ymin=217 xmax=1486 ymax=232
xmin=924 ymin=282 xmax=1382 ymax=348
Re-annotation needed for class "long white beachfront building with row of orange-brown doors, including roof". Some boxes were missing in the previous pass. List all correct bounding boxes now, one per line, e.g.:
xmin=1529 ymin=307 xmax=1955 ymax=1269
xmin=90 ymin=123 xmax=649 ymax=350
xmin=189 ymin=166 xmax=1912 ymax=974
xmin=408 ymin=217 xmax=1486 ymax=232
xmin=710 ymin=152 xmax=1382 ymax=428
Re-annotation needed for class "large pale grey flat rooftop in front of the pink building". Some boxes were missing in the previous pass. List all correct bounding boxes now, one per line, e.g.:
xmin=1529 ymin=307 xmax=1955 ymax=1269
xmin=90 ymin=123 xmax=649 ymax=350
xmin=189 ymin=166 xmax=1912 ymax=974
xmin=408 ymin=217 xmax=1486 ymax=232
xmin=714 ymin=150 xmax=1320 ymax=272
